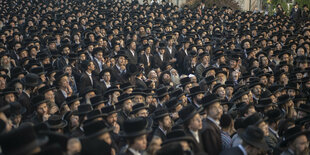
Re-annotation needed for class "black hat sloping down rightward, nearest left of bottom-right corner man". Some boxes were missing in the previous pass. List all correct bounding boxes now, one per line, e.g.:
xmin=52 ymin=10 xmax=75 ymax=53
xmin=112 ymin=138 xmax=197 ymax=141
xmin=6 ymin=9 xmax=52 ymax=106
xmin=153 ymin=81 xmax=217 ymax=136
xmin=238 ymin=125 xmax=269 ymax=151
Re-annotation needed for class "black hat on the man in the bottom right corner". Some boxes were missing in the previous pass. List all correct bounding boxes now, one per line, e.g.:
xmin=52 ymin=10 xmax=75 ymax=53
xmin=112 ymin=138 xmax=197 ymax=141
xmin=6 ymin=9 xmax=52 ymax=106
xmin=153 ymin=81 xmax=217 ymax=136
xmin=279 ymin=125 xmax=310 ymax=147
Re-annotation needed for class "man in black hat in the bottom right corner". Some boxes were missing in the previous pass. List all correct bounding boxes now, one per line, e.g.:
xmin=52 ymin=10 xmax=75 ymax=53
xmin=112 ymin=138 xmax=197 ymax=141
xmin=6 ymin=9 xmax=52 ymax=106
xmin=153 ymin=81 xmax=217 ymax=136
xmin=279 ymin=126 xmax=310 ymax=155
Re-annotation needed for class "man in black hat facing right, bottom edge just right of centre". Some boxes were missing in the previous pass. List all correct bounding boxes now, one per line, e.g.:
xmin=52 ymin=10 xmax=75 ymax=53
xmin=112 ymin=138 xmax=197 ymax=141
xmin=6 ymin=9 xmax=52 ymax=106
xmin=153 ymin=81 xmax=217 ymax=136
xmin=153 ymin=109 xmax=172 ymax=141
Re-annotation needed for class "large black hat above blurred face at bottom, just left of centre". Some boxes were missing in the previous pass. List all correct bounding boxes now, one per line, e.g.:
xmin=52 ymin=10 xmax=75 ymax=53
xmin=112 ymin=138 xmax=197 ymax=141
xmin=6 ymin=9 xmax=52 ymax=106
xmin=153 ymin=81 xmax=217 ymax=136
xmin=120 ymin=117 xmax=152 ymax=138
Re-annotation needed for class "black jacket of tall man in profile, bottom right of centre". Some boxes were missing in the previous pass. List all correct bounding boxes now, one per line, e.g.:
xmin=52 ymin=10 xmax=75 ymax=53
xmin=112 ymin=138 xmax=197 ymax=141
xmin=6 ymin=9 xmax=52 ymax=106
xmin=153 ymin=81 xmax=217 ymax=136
xmin=201 ymin=119 xmax=222 ymax=155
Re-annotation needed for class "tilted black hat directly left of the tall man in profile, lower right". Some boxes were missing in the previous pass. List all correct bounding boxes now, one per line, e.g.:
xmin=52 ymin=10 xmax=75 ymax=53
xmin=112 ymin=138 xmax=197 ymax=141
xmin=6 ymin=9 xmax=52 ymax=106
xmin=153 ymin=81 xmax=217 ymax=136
xmin=176 ymin=105 xmax=203 ymax=124
